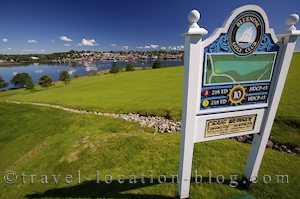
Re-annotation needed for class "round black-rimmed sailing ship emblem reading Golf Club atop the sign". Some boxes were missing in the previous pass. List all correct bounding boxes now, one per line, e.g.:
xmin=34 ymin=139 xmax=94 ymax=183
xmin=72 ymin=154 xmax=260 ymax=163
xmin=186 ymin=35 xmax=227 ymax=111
xmin=230 ymin=13 xmax=263 ymax=56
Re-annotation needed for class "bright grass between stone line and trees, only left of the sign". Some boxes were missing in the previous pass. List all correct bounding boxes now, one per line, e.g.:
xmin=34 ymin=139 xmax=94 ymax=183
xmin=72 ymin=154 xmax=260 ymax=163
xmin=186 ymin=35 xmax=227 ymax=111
xmin=0 ymin=67 xmax=183 ymax=119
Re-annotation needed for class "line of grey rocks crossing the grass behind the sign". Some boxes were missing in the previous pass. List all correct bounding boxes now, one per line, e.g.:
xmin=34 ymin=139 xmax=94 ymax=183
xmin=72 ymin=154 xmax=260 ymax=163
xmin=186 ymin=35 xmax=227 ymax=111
xmin=4 ymin=100 xmax=300 ymax=155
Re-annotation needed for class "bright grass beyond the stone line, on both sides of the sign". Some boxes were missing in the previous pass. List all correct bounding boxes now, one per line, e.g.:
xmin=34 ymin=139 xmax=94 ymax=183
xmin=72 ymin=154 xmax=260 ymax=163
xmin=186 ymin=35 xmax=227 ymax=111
xmin=0 ymin=53 xmax=300 ymax=146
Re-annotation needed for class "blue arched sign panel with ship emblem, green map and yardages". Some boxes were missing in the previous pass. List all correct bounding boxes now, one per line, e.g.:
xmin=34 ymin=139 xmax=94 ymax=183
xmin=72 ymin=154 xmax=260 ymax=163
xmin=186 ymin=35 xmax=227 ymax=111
xmin=200 ymin=11 xmax=279 ymax=110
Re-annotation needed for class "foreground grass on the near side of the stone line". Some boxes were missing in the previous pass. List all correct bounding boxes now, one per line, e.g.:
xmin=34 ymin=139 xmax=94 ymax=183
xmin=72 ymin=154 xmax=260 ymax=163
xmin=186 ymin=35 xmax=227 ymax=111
xmin=0 ymin=103 xmax=300 ymax=198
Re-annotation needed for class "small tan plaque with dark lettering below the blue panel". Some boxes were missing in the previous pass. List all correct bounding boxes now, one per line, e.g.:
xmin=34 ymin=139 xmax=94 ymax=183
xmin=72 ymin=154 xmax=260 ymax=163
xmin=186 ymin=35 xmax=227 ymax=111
xmin=205 ymin=114 xmax=257 ymax=137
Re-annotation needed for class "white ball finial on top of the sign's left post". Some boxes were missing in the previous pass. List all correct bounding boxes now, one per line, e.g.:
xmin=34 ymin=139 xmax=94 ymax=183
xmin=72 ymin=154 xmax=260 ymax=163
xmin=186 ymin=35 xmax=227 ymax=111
xmin=187 ymin=10 xmax=207 ymax=35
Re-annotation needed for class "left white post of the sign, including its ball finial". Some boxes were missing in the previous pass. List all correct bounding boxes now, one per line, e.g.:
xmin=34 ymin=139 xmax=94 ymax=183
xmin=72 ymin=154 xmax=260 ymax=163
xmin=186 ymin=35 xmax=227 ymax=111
xmin=179 ymin=10 xmax=207 ymax=197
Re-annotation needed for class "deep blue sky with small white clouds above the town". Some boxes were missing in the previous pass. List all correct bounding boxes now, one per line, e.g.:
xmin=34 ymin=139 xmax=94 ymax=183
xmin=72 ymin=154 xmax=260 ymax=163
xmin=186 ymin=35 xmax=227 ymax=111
xmin=0 ymin=0 xmax=300 ymax=54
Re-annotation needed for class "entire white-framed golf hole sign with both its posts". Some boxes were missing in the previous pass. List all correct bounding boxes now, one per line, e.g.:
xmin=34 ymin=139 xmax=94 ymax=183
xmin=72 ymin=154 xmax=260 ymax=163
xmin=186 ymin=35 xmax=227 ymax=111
xmin=178 ymin=5 xmax=300 ymax=198
